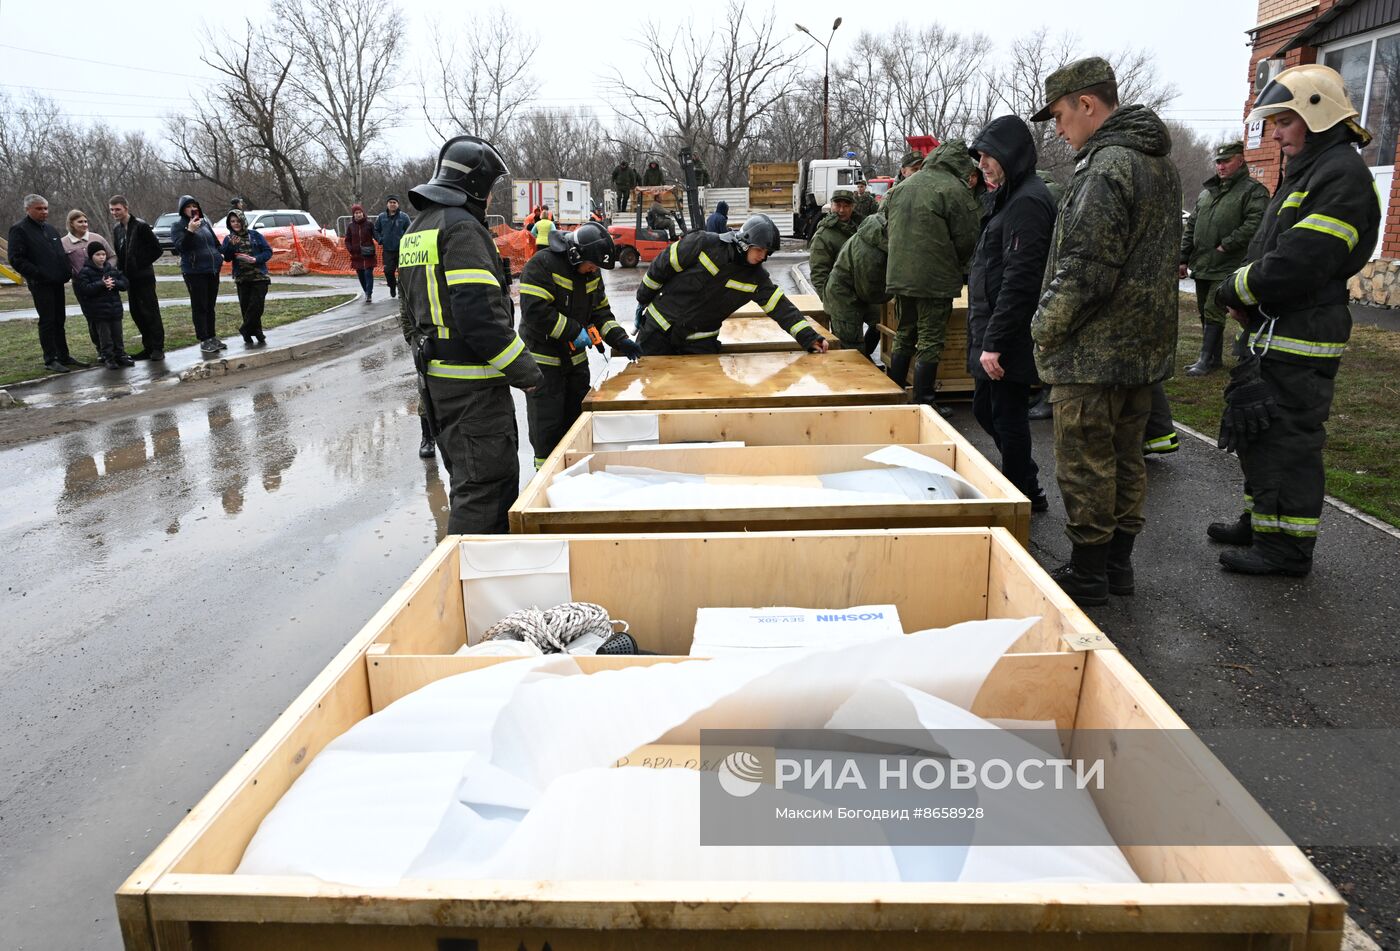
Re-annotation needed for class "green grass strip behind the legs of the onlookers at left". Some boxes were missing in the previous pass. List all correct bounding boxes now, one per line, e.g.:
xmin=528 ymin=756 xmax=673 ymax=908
xmin=0 ymin=294 xmax=358 ymax=387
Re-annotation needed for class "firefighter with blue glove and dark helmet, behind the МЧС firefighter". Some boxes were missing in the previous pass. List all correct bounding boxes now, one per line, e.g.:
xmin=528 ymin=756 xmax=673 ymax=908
xmin=521 ymin=221 xmax=641 ymax=469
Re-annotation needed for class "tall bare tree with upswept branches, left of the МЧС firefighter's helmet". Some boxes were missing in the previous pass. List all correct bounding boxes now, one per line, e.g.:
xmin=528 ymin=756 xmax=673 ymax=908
xmin=276 ymin=0 xmax=402 ymax=202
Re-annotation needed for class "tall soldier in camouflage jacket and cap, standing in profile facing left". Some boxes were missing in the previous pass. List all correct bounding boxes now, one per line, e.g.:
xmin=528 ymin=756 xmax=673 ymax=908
xmin=1030 ymin=57 xmax=1182 ymax=605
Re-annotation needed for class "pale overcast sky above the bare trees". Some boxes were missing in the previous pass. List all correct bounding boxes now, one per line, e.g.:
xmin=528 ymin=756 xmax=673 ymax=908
xmin=0 ymin=0 xmax=1257 ymax=155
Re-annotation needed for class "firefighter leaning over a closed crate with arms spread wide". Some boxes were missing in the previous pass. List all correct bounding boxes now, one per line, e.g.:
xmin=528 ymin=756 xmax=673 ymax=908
xmin=637 ymin=214 xmax=827 ymax=354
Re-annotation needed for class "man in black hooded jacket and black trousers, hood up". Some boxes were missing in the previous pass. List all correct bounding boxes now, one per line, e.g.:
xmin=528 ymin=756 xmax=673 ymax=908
xmin=967 ymin=116 xmax=1056 ymax=511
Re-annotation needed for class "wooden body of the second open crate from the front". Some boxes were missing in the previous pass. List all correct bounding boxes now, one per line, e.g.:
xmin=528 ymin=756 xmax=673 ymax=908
xmin=510 ymin=406 xmax=1030 ymax=545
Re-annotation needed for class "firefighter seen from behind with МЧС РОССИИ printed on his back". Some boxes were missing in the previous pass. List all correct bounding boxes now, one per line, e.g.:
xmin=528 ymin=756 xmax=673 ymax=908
xmin=399 ymin=136 xmax=542 ymax=534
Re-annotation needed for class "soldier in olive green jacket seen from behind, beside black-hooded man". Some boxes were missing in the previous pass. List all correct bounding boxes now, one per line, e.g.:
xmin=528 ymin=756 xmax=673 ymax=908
xmin=884 ymin=139 xmax=981 ymax=416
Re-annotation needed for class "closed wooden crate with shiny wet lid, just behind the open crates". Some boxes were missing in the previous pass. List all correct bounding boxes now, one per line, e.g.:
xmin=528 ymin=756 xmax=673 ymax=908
xmin=584 ymin=350 xmax=906 ymax=412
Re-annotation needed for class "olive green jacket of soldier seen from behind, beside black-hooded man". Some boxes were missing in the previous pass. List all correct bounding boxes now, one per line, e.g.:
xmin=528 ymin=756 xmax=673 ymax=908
xmin=885 ymin=139 xmax=981 ymax=300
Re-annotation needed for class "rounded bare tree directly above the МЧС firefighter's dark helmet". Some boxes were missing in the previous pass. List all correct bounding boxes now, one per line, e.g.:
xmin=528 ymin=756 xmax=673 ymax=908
xmin=419 ymin=7 xmax=539 ymax=146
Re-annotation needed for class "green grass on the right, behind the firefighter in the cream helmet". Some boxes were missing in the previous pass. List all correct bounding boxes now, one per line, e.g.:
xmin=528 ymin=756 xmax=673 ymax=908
xmin=1166 ymin=296 xmax=1400 ymax=527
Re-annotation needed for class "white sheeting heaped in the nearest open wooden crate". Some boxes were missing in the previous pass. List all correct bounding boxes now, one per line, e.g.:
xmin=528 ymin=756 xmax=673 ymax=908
xmin=238 ymin=620 xmax=1136 ymax=885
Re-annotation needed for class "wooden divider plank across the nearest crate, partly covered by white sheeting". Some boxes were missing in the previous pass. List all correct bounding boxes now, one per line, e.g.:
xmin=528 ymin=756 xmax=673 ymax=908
xmin=370 ymin=653 xmax=1084 ymax=730
